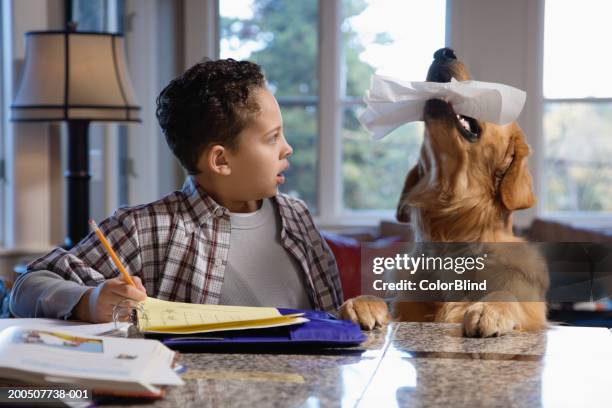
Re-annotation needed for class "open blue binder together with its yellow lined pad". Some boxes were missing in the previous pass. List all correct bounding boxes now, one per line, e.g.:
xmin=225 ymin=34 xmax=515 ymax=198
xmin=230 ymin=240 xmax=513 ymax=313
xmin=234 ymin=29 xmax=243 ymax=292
xmin=127 ymin=298 xmax=366 ymax=352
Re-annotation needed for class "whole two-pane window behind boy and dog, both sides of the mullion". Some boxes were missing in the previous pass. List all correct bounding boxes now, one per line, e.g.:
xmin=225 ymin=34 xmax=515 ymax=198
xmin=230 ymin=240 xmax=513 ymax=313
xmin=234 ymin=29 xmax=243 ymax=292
xmin=219 ymin=0 xmax=446 ymax=219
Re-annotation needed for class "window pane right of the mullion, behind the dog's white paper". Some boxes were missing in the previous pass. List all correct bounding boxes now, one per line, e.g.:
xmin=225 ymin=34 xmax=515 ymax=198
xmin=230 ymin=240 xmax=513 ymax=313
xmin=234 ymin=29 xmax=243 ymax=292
xmin=341 ymin=0 xmax=446 ymax=210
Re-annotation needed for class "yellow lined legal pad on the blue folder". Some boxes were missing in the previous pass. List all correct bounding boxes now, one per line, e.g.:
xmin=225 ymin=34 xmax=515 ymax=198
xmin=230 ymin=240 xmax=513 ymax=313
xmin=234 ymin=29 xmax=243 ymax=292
xmin=137 ymin=298 xmax=308 ymax=334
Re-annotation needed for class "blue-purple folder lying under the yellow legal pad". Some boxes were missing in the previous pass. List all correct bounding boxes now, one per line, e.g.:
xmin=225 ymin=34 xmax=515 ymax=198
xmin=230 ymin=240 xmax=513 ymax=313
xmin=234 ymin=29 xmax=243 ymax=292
xmin=145 ymin=309 xmax=366 ymax=352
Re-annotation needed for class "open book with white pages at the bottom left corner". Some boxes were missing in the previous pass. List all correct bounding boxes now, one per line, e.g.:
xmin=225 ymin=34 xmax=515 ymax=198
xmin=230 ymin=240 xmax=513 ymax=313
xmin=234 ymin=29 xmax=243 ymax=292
xmin=0 ymin=325 xmax=183 ymax=397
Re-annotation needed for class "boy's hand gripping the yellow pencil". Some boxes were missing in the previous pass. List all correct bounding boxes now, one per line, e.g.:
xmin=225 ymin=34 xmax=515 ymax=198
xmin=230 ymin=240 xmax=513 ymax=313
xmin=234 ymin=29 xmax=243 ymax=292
xmin=74 ymin=276 xmax=147 ymax=323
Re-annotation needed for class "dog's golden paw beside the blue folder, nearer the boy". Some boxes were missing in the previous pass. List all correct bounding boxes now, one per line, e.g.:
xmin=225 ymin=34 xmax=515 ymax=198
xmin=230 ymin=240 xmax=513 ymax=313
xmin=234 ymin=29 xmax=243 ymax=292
xmin=340 ymin=296 xmax=390 ymax=330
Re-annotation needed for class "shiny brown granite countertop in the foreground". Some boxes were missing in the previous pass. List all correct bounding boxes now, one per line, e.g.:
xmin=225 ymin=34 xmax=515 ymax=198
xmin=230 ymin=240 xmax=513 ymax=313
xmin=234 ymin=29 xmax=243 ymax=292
xmin=106 ymin=323 xmax=612 ymax=408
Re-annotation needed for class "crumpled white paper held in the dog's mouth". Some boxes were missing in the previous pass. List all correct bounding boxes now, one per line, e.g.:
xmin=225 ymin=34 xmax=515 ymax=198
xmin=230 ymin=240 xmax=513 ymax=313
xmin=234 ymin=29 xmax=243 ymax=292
xmin=359 ymin=75 xmax=527 ymax=139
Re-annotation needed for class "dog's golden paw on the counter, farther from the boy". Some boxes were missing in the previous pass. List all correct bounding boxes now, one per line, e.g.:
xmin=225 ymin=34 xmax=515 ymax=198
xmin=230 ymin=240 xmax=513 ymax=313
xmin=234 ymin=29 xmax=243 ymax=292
xmin=463 ymin=302 xmax=516 ymax=337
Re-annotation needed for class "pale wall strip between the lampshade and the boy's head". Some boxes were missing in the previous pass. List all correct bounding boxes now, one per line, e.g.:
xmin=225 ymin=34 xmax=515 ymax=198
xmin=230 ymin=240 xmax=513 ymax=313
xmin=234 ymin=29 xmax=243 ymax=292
xmin=126 ymin=0 xmax=183 ymax=205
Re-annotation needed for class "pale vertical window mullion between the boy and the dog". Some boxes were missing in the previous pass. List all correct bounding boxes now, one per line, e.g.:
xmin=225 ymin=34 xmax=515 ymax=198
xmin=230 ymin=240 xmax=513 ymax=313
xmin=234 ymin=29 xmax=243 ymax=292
xmin=317 ymin=0 xmax=342 ymax=223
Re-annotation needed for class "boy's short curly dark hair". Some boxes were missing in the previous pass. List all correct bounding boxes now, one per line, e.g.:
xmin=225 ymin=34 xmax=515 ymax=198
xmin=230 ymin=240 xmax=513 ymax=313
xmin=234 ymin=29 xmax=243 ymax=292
xmin=156 ymin=58 xmax=265 ymax=174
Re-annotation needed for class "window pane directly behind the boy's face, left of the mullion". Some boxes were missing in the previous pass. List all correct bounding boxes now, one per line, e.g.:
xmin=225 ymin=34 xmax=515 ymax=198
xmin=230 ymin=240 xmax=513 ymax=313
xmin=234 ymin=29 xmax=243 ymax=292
xmin=219 ymin=0 xmax=319 ymax=212
